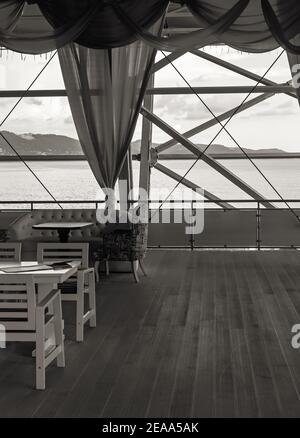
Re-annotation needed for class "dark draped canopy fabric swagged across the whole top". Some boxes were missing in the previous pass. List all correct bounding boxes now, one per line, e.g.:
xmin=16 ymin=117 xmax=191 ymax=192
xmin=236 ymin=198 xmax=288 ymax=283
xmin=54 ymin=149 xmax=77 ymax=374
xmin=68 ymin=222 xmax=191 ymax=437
xmin=0 ymin=0 xmax=300 ymax=53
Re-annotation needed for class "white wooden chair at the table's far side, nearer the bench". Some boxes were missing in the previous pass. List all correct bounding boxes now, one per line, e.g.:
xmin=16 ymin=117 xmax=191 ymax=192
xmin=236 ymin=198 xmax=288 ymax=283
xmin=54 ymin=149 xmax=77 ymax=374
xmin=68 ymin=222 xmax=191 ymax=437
xmin=37 ymin=242 xmax=96 ymax=342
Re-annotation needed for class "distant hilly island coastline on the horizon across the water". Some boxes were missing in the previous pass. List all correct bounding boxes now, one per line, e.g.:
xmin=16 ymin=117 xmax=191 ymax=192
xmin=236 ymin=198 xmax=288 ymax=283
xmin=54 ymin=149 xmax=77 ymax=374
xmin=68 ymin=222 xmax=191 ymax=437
xmin=0 ymin=131 xmax=300 ymax=159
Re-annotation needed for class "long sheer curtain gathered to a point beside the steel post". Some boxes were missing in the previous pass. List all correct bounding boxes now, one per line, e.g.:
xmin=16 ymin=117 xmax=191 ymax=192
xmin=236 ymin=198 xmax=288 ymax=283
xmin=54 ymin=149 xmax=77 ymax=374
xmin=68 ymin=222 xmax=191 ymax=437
xmin=58 ymin=19 xmax=162 ymax=188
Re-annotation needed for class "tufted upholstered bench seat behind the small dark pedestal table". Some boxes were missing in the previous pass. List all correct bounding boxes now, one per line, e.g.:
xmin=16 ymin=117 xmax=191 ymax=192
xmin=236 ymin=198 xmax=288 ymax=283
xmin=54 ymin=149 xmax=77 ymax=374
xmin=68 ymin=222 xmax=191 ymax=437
xmin=8 ymin=209 xmax=103 ymax=260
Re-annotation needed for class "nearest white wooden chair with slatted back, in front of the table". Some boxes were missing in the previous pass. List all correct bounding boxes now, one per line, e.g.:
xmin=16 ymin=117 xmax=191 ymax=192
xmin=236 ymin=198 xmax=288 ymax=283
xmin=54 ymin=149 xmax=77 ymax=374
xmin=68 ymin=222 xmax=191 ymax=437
xmin=0 ymin=274 xmax=65 ymax=389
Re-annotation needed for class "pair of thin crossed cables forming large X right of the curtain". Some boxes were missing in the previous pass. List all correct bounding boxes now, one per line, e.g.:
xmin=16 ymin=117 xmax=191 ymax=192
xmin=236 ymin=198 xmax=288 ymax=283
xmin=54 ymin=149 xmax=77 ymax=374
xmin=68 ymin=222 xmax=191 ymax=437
xmin=151 ymin=50 xmax=300 ymax=221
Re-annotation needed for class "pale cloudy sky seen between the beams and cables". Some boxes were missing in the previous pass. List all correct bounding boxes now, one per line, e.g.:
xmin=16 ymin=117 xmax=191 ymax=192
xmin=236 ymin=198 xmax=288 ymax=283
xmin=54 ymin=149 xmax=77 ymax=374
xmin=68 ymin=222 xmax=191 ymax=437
xmin=0 ymin=47 xmax=300 ymax=151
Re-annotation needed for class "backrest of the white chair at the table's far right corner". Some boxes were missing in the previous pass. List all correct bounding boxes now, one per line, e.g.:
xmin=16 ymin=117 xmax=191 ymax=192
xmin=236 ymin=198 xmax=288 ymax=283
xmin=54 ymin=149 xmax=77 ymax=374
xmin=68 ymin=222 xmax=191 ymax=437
xmin=37 ymin=242 xmax=89 ymax=269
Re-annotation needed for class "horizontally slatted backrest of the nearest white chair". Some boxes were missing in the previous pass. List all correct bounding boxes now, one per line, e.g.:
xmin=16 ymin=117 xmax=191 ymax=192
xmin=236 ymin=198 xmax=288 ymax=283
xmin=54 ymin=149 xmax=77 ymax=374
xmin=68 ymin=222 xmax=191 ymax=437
xmin=0 ymin=274 xmax=36 ymax=332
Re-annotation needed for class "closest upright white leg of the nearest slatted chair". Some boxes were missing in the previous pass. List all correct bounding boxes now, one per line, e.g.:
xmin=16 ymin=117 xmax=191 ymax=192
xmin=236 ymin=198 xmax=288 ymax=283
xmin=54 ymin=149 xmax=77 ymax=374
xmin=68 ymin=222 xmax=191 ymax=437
xmin=35 ymin=310 xmax=46 ymax=389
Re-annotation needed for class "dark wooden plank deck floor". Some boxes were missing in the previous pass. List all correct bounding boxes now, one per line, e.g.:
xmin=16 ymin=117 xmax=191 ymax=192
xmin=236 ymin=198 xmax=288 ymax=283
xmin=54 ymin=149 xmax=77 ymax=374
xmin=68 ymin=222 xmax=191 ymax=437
xmin=0 ymin=251 xmax=300 ymax=417
